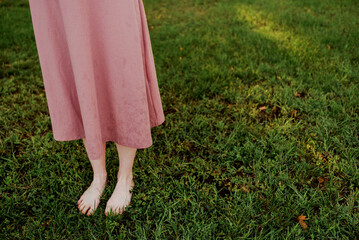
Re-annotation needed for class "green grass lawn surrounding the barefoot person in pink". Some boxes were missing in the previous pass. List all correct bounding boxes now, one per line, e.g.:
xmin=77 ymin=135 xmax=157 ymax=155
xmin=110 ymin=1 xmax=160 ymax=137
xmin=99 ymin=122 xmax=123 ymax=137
xmin=0 ymin=0 xmax=359 ymax=239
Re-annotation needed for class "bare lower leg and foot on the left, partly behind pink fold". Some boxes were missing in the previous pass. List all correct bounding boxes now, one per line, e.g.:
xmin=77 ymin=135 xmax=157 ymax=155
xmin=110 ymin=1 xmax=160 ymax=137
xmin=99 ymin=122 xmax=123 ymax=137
xmin=77 ymin=138 xmax=107 ymax=216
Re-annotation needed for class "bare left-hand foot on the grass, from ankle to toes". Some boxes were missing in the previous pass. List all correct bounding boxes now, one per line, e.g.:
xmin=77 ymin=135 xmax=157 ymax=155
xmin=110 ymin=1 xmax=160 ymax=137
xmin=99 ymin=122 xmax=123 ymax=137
xmin=77 ymin=175 xmax=107 ymax=216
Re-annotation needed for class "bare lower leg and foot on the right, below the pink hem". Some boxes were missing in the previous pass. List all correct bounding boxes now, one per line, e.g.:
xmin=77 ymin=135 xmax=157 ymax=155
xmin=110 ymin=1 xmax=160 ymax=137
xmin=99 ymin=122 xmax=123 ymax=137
xmin=105 ymin=143 xmax=137 ymax=216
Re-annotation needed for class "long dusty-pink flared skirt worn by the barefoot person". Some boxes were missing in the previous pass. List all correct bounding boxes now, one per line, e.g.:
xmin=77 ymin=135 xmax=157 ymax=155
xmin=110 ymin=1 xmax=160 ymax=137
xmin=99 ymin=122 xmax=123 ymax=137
xmin=29 ymin=0 xmax=165 ymax=159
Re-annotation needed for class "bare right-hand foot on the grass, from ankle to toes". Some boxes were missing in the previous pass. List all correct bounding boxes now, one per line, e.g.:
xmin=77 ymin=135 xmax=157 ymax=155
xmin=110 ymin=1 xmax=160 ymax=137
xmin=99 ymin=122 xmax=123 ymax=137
xmin=105 ymin=176 xmax=135 ymax=216
